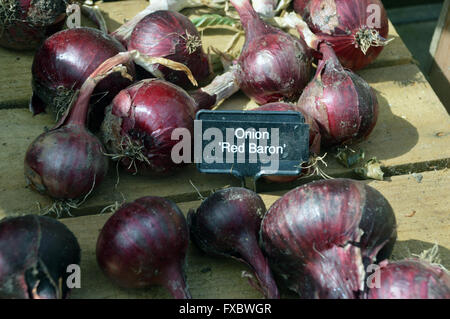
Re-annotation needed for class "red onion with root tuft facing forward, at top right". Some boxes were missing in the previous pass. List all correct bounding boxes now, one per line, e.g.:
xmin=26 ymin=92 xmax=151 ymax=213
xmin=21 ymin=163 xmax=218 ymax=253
xmin=294 ymin=0 xmax=389 ymax=71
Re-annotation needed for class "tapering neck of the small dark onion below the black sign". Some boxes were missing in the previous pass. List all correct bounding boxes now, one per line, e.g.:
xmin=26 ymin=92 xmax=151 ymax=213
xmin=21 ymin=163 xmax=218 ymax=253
xmin=238 ymin=235 xmax=280 ymax=299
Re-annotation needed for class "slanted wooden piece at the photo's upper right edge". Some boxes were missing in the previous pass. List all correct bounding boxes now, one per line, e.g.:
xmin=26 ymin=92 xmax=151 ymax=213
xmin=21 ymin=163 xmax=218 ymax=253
xmin=429 ymin=0 xmax=450 ymax=113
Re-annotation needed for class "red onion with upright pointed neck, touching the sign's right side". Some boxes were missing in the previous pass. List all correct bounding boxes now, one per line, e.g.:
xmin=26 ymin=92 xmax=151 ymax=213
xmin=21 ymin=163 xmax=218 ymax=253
xmin=297 ymin=43 xmax=378 ymax=146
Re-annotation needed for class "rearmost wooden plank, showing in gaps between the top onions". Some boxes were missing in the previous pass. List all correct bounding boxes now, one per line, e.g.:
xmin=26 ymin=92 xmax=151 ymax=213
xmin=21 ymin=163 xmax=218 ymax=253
xmin=0 ymin=0 xmax=412 ymax=108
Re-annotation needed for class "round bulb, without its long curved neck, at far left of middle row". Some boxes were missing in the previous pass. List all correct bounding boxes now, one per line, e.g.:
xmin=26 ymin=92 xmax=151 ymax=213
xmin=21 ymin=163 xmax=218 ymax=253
xmin=24 ymin=126 xmax=108 ymax=199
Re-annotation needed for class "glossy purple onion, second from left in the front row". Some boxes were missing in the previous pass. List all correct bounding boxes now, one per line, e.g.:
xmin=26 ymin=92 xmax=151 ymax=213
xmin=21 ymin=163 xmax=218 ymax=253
xmin=96 ymin=196 xmax=191 ymax=299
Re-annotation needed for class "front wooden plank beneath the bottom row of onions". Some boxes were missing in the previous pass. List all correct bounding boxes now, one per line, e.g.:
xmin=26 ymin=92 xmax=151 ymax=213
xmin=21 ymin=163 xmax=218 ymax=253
xmin=62 ymin=170 xmax=450 ymax=298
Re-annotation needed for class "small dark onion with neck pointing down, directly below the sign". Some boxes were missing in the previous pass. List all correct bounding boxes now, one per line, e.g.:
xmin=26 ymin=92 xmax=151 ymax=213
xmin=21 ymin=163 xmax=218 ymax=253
xmin=188 ymin=187 xmax=280 ymax=298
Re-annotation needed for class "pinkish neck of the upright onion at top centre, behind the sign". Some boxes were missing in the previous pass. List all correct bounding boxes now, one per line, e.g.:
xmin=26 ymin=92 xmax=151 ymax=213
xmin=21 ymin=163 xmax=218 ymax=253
xmin=230 ymin=0 xmax=268 ymax=41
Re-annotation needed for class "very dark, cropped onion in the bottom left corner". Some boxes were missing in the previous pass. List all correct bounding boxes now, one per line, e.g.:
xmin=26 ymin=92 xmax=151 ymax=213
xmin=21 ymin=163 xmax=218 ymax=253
xmin=0 ymin=215 xmax=80 ymax=299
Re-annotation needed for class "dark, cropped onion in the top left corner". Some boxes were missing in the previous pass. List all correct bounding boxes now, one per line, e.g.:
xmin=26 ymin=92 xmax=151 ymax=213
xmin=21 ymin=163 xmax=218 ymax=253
xmin=0 ymin=0 xmax=67 ymax=50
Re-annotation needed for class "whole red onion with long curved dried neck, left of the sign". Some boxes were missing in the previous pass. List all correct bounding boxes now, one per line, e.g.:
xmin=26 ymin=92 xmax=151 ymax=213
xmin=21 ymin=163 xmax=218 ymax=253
xmin=25 ymin=52 xmax=137 ymax=212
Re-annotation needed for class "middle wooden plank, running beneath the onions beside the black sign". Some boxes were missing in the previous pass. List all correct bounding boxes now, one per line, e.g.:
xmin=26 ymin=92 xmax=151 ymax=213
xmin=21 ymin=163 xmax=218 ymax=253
xmin=0 ymin=64 xmax=450 ymax=217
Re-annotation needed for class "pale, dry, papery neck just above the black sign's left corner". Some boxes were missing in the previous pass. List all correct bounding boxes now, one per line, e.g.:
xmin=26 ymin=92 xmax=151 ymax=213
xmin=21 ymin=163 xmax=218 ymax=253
xmin=191 ymin=67 xmax=239 ymax=111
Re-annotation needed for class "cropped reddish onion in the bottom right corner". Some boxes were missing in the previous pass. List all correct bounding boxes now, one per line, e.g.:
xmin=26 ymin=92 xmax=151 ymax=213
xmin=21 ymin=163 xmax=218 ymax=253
xmin=367 ymin=259 xmax=450 ymax=299
